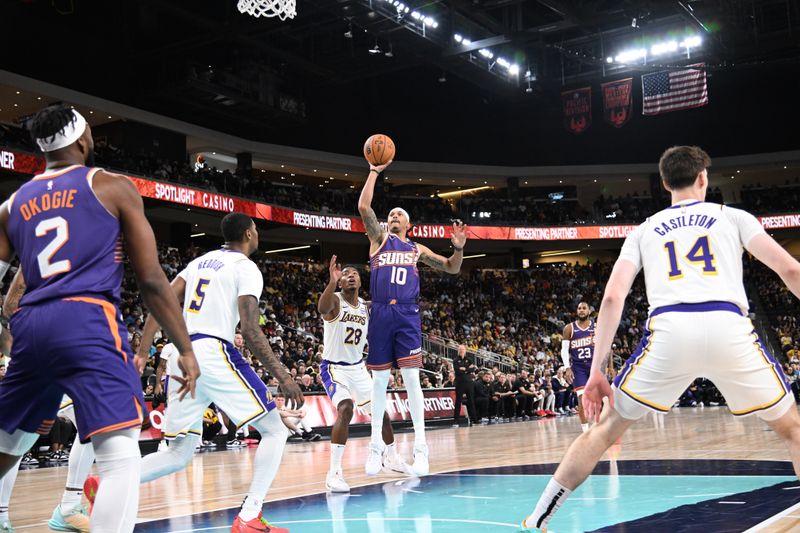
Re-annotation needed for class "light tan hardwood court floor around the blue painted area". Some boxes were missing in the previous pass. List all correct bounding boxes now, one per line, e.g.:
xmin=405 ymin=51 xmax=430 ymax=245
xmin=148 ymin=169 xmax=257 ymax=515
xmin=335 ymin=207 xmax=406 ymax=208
xmin=10 ymin=408 xmax=800 ymax=532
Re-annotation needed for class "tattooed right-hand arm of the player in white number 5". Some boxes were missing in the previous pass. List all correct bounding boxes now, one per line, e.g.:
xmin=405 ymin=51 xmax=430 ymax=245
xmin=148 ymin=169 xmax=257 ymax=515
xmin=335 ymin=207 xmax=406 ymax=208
xmin=239 ymin=294 xmax=305 ymax=408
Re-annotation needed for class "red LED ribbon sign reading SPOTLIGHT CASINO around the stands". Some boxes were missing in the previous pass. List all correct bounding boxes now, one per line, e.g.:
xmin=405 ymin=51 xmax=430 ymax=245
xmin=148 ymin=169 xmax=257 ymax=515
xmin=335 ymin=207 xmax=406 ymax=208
xmin=0 ymin=147 xmax=800 ymax=241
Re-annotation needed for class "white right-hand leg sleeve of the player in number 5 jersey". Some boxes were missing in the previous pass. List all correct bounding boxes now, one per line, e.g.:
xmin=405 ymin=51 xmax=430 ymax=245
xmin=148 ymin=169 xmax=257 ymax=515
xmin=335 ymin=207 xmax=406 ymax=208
xmin=239 ymin=409 xmax=289 ymax=522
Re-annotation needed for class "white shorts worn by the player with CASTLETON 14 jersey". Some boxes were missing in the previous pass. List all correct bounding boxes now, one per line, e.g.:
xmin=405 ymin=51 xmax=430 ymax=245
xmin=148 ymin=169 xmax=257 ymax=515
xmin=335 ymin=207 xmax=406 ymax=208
xmin=614 ymin=302 xmax=794 ymax=421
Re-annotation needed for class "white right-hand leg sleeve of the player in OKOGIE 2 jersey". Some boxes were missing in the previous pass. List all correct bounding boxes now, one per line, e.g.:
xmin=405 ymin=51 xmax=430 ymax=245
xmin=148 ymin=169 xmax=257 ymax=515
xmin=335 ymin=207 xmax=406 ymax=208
xmin=91 ymin=429 xmax=142 ymax=533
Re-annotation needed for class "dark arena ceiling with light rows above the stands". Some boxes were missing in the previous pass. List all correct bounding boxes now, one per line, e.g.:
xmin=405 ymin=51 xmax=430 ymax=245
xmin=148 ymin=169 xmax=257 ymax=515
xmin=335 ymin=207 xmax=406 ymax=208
xmin=0 ymin=0 xmax=800 ymax=165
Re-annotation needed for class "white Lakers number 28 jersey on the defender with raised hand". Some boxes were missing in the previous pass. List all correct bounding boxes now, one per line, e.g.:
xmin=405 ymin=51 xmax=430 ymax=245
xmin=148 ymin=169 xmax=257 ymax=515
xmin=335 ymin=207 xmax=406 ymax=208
xmin=322 ymin=292 xmax=369 ymax=364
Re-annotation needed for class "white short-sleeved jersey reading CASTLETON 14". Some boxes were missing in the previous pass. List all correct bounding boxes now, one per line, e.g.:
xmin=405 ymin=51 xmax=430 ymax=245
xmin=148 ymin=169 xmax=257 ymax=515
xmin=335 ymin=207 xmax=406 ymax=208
xmin=619 ymin=200 xmax=764 ymax=314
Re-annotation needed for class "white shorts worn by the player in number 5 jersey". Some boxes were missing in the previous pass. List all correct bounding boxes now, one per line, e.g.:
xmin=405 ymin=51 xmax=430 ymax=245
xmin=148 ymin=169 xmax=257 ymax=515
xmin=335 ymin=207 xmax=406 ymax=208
xmin=164 ymin=335 xmax=275 ymax=440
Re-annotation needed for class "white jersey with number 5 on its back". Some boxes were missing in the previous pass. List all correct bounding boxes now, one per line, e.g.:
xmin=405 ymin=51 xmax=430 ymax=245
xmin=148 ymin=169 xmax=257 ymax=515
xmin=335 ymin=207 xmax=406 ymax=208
xmin=178 ymin=248 xmax=264 ymax=344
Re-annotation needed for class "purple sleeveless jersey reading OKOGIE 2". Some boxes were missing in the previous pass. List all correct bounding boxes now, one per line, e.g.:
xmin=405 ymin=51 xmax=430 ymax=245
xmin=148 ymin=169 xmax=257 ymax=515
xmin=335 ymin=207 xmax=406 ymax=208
xmin=8 ymin=165 xmax=123 ymax=306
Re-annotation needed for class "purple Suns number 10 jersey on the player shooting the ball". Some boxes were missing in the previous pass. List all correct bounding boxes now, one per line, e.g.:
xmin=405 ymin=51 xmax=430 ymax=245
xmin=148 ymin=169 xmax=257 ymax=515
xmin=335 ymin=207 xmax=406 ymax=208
xmin=370 ymin=235 xmax=419 ymax=304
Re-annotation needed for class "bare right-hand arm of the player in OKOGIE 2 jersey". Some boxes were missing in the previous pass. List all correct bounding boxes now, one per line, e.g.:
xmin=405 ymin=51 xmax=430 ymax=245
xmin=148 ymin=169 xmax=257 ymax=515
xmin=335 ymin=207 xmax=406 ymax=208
xmin=93 ymin=171 xmax=200 ymax=398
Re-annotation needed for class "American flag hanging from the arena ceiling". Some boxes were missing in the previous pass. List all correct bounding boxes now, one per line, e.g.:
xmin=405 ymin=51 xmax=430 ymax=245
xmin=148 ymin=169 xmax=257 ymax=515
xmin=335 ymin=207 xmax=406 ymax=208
xmin=642 ymin=65 xmax=708 ymax=115
